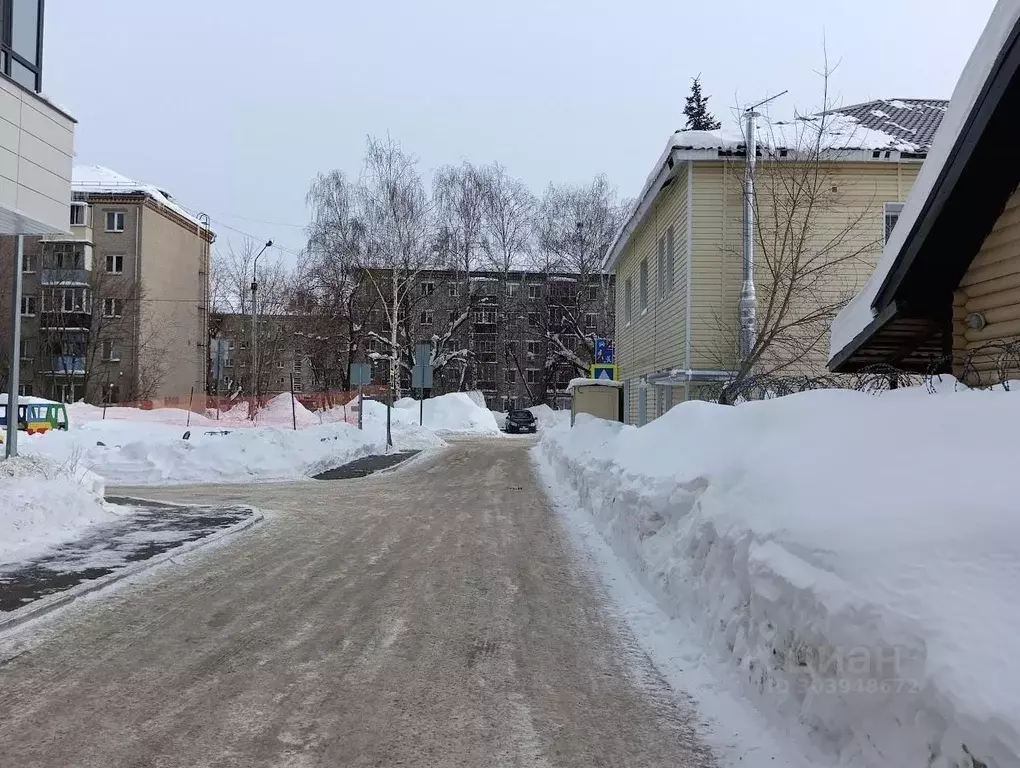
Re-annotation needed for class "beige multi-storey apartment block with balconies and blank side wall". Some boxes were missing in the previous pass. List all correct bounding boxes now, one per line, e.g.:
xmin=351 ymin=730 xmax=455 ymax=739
xmin=3 ymin=166 xmax=214 ymax=403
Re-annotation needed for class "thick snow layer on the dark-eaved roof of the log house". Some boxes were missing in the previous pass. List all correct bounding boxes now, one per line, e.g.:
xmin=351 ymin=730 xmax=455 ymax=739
xmin=829 ymin=0 xmax=1020 ymax=359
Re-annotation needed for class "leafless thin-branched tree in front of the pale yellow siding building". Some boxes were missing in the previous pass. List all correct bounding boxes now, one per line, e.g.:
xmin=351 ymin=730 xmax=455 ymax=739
xmin=714 ymin=63 xmax=882 ymax=402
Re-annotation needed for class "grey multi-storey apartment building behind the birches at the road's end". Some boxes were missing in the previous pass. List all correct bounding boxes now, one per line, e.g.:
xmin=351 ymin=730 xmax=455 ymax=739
xmin=363 ymin=269 xmax=614 ymax=410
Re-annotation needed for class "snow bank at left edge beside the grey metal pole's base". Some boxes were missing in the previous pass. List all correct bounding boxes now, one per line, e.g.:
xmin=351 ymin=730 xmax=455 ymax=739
xmin=0 ymin=456 xmax=116 ymax=564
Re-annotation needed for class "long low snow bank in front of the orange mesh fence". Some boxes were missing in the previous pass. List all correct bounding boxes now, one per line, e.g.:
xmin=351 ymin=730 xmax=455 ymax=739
xmin=18 ymin=418 xmax=385 ymax=484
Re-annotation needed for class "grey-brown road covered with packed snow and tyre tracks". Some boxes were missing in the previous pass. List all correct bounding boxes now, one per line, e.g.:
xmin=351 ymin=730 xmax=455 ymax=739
xmin=0 ymin=440 xmax=714 ymax=768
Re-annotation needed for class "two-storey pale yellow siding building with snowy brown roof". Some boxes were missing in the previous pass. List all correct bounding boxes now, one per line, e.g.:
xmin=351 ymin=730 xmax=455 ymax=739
xmin=607 ymin=100 xmax=947 ymax=424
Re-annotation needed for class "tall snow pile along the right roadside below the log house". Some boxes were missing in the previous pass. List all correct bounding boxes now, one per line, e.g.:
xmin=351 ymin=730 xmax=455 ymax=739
xmin=536 ymin=390 xmax=1020 ymax=768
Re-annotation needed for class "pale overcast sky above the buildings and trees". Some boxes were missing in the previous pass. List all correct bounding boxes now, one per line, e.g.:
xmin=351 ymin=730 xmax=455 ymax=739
xmin=43 ymin=0 xmax=995 ymax=261
